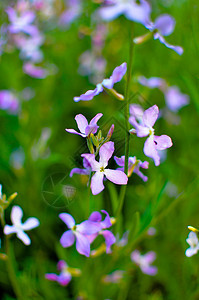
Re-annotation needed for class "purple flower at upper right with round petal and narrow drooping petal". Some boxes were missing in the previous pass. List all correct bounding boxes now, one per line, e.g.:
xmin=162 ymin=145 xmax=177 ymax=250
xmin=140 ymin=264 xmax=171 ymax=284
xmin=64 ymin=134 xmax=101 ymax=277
xmin=145 ymin=14 xmax=183 ymax=55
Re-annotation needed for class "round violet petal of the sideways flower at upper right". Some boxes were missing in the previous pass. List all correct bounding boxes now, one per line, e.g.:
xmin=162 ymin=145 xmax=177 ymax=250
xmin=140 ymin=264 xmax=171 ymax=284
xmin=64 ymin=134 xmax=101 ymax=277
xmin=154 ymin=14 xmax=176 ymax=36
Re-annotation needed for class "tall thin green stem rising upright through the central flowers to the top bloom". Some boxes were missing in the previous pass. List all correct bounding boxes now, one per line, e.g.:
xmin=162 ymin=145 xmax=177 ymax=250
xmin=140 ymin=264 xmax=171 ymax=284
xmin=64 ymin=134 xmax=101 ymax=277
xmin=116 ymin=27 xmax=134 ymax=217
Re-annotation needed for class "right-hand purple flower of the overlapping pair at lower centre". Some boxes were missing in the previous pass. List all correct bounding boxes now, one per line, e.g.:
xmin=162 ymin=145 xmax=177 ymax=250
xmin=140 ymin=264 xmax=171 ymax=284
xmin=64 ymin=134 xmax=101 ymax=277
xmin=88 ymin=210 xmax=116 ymax=253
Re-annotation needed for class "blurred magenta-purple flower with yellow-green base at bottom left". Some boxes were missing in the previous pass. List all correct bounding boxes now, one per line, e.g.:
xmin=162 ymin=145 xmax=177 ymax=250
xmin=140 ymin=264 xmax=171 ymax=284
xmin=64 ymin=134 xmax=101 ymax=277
xmin=45 ymin=260 xmax=81 ymax=286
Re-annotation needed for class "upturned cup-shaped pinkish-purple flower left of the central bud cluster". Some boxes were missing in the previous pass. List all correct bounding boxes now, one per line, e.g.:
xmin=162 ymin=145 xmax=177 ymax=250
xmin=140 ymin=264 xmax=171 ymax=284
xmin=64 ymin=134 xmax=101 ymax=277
xmin=66 ymin=113 xmax=103 ymax=137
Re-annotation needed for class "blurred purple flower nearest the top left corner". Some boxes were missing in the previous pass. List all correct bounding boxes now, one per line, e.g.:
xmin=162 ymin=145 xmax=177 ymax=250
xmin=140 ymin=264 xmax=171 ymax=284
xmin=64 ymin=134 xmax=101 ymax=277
xmin=6 ymin=7 xmax=38 ymax=35
